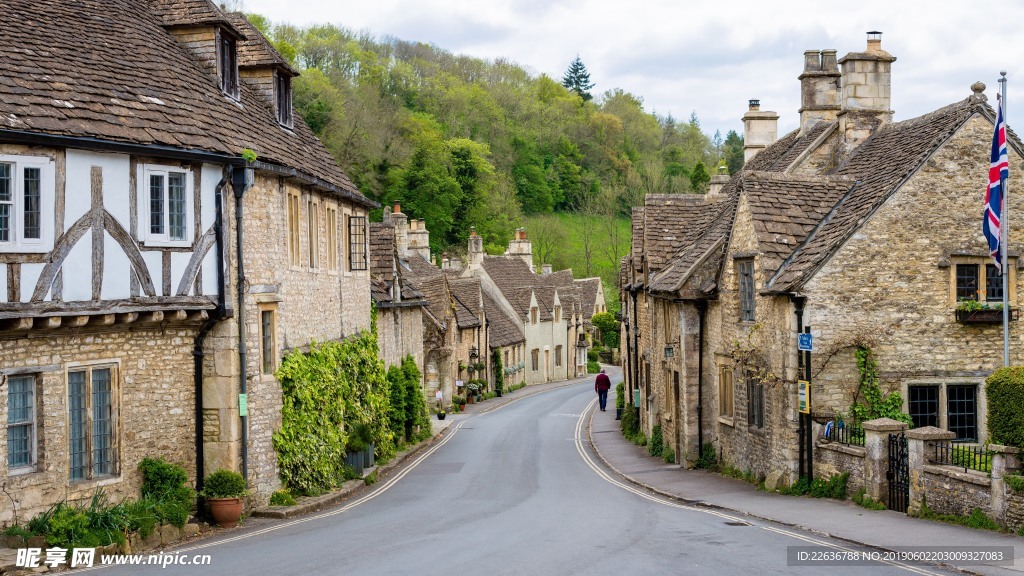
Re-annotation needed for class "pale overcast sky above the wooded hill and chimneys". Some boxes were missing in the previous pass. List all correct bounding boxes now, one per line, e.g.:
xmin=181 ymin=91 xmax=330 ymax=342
xmin=236 ymin=0 xmax=1024 ymax=136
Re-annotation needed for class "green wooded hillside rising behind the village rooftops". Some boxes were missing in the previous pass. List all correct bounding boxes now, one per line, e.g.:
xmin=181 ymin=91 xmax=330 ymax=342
xmin=249 ymin=14 xmax=742 ymax=297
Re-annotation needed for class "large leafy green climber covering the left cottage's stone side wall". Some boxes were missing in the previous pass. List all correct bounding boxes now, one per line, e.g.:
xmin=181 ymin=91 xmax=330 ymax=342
xmin=273 ymin=330 xmax=395 ymax=494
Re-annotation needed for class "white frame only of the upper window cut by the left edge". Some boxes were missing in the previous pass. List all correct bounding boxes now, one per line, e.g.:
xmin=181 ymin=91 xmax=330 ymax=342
xmin=0 ymin=155 xmax=56 ymax=253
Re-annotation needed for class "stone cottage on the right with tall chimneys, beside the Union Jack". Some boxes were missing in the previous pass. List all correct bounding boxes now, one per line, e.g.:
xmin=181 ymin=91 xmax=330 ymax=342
xmin=623 ymin=33 xmax=1024 ymax=481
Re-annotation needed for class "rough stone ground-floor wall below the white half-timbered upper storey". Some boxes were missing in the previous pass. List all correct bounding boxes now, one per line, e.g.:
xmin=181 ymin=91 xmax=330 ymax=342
xmin=0 ymin=325 xmax=197 ymax=526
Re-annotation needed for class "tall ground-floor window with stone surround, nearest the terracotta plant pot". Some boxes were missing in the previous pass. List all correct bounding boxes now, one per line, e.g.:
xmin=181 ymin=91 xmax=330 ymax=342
xmin=68 ymin=366 xmax=117 ymax=481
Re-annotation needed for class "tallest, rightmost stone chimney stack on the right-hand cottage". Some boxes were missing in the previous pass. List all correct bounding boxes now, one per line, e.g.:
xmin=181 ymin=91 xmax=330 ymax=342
xmin=839 ymin=31 xmax=896 ymax=156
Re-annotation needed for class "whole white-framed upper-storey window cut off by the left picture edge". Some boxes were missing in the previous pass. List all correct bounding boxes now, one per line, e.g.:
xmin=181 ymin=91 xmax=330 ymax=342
xmin=0 ymin=156 xmax=54 ymax=252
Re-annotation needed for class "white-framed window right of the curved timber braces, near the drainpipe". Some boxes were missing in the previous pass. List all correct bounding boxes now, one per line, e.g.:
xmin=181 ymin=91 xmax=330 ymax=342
xmin=138 ymin=166 xmax=194 ymax=246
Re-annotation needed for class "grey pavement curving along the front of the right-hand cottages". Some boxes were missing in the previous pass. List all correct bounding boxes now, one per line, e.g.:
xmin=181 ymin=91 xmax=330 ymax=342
xmin=588 ymin=368 xmax=1024 ymax=575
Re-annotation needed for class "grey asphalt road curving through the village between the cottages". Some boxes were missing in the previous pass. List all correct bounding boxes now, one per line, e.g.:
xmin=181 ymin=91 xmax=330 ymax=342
xmin=101 ymin=382 xmax=966 ymax=576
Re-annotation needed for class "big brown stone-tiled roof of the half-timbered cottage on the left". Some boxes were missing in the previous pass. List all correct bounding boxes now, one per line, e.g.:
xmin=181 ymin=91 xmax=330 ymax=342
xmin=0 ymin=0 xmax=376 ymax=206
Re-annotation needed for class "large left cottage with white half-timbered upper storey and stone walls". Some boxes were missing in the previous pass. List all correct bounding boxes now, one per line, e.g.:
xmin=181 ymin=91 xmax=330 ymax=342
xmin=0 ymin=0 xmax=374 ymax=516
